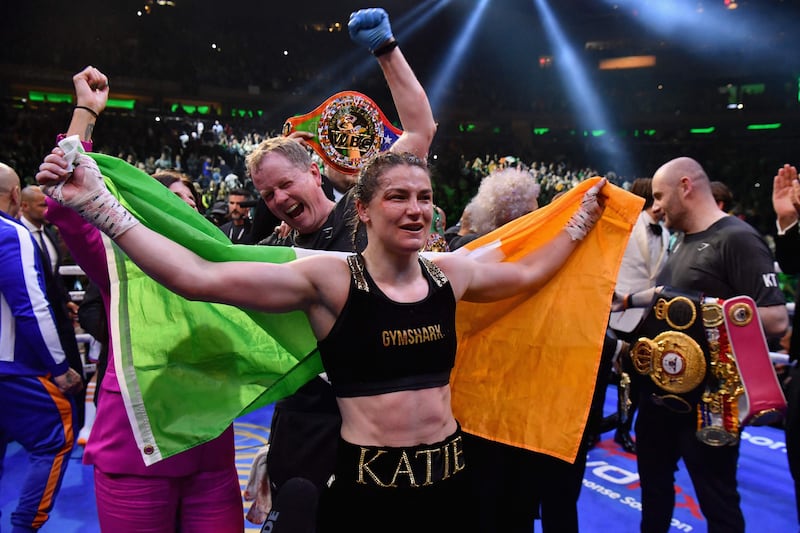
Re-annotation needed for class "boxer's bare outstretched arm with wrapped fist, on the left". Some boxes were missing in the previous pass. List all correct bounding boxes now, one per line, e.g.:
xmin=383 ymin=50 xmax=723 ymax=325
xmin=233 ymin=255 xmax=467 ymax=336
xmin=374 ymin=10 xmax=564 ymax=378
xmin=36 ymin=148 xmax=347 ymax=327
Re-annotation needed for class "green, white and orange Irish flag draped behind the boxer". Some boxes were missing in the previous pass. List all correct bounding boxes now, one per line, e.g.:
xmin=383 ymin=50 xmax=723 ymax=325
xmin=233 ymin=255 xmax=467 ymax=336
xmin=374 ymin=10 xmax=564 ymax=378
xmin=89 ymin=154 xmax=642 ymax=464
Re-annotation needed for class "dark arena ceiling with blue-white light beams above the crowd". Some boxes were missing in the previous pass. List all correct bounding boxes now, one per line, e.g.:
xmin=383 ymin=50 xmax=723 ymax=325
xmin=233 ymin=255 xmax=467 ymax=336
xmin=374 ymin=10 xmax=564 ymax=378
xmin=0 ymin=0 xmax=800 ymax=105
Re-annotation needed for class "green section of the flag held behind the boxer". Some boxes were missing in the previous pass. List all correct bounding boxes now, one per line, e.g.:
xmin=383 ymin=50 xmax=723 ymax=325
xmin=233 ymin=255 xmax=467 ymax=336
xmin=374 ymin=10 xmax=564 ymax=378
xmin=89 ymin=153 xmax=322 ymax=463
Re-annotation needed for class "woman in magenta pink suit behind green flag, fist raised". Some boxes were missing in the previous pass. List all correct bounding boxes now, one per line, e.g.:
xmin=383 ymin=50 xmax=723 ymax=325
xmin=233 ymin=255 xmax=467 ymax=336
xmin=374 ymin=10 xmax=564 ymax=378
xmin=47 ymin=67 xmax=244 ymax=533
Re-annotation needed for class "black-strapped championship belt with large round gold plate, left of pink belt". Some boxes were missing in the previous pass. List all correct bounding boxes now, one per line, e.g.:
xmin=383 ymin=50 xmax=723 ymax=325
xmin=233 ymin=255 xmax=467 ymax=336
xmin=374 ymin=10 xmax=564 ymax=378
xmin=630 ymin=287 xmax=709 ymax=413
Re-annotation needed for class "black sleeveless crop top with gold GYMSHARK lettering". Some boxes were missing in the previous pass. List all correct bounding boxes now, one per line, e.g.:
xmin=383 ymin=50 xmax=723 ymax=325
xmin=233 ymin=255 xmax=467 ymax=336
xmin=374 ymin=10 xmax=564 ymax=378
xmin=317 ymin=254 xmax=457 ymax=397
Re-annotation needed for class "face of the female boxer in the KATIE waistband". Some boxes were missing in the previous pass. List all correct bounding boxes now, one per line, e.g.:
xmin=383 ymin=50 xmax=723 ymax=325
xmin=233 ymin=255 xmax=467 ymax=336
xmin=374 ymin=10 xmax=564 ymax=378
xmin=357 ymin=159 xmax=433 ymax=252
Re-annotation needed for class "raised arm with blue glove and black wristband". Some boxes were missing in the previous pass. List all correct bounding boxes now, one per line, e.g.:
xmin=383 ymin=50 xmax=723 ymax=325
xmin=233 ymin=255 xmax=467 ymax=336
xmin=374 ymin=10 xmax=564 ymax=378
xmin=347 ymin=8 xmax=436 ymax=160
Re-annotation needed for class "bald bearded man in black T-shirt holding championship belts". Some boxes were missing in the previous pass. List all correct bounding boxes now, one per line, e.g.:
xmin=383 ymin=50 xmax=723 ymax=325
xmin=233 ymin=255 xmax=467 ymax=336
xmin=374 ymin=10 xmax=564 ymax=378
xmin=635 ymin=157 xmax=789 ymax=533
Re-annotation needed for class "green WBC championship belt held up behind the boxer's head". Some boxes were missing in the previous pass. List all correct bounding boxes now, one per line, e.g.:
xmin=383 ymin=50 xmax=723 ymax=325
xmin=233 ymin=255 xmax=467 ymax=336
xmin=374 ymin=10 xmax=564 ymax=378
xmin=283 ymin=91 xmax=403 ymax=174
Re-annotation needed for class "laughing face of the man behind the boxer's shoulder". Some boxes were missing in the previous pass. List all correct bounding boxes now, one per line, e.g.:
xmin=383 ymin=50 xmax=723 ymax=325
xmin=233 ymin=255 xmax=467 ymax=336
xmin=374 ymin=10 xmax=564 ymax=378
xmin=252 ymin=152 xmax=333 ymax=234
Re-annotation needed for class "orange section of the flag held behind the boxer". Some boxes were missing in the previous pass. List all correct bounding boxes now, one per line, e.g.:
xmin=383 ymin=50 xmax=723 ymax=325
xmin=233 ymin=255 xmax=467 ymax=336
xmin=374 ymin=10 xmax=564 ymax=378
xmin=451 ymin=178 xmax=644 ymax=462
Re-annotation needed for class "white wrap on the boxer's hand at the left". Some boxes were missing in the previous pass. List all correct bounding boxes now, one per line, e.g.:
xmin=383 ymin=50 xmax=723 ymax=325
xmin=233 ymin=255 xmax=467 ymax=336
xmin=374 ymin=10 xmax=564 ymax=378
xmin=45 ymin=153 xmax=139 ymax=239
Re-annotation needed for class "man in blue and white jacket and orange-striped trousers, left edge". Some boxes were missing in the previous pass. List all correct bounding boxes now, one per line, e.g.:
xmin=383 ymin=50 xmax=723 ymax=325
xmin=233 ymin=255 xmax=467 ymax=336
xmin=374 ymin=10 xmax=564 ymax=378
xmin=0 ymin=163 xmax=82 ymax=531
